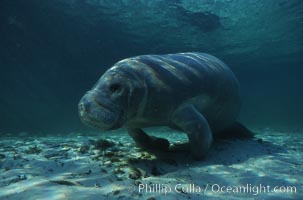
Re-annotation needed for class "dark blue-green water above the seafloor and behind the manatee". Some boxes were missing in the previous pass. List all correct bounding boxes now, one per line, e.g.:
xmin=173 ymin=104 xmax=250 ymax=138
xmin=0 ymin=0 xmax=303 ymax=133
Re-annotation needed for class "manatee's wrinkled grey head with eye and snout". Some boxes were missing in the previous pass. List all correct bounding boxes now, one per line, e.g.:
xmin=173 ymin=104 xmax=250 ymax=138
xmin=78 ymin=66 xmax=131 ymax=130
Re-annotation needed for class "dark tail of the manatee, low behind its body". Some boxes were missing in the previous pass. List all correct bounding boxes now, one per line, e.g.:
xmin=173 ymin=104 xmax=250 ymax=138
xmin=218 ymin=122 xmax=254 ymax=139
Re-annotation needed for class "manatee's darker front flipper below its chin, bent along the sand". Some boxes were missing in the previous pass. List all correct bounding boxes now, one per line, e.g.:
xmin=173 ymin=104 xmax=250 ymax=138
xmin=126 ymin=128 xmax=169 ymax=151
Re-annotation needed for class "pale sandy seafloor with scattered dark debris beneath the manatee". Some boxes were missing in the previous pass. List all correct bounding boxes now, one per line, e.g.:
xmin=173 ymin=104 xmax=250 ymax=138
xmin=0 ymin=128 xmax=303 ymax=200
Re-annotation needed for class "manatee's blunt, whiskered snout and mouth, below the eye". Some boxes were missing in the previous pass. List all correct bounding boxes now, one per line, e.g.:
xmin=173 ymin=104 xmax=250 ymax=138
xmin=78 ymin=91 xmax=120 ymax=130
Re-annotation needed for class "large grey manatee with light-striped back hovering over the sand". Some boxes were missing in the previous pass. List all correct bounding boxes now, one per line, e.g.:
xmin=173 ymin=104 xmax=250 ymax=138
xmin=78 ymin=52 xmax=252 ymax=159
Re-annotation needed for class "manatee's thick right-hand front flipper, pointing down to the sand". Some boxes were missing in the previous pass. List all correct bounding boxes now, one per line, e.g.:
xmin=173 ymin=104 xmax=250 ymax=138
xmin=172 ymin=105 xmax=213 ymax=160
